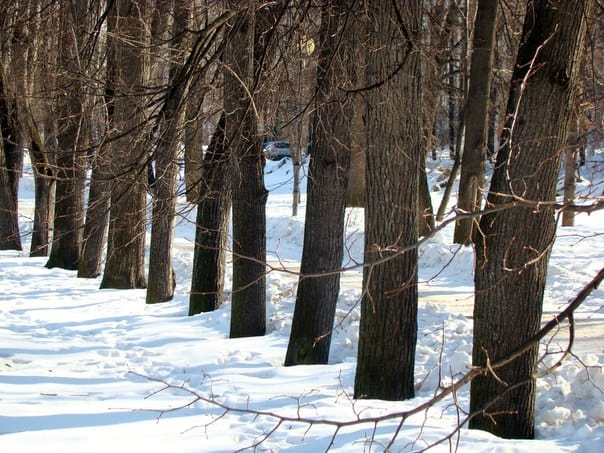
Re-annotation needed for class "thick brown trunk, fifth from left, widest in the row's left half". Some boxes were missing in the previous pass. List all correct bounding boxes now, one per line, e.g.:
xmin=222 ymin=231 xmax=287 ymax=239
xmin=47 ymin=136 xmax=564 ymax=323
xmin=101 ymin=0 xmax=147 ymax=289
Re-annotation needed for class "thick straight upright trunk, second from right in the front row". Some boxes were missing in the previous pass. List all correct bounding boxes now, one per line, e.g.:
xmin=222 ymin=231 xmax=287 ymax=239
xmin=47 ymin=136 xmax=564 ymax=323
xmin=354 ymin=1 xmax=423 ymax=400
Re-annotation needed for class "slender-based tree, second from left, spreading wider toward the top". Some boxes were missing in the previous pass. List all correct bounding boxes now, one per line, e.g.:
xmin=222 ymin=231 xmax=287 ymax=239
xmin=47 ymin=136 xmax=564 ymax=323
xmin=2 ymin=1 xmax=58 ymax=256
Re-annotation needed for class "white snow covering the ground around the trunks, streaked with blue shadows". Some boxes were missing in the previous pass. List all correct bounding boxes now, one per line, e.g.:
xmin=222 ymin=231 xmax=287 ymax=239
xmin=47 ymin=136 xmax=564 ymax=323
xmin=0 ymin=151 xmax=604 ymax=453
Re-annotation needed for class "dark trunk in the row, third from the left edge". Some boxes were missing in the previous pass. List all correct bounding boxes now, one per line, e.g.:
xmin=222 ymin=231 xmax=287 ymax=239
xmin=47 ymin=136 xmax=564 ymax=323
xmin=46 ymin=0 xmax=88 ymax=270
